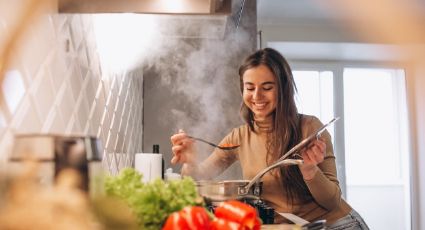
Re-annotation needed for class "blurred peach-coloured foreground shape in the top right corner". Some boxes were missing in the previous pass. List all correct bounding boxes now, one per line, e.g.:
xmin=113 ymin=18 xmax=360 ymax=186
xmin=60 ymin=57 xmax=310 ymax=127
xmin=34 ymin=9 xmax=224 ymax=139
xmin=318 ymin=0 xmax=425 ymax=56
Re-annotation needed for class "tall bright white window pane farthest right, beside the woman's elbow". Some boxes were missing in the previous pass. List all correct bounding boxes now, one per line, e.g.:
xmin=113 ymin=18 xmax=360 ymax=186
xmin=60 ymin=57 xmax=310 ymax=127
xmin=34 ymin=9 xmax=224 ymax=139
xmin=344 ymin=68 xmax=410 ymax=229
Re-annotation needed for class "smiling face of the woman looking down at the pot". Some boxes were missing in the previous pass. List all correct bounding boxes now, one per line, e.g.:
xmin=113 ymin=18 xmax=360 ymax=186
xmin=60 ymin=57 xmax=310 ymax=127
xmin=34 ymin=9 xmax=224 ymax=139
xmin=242 ymin=65 xmax=277 ymax=120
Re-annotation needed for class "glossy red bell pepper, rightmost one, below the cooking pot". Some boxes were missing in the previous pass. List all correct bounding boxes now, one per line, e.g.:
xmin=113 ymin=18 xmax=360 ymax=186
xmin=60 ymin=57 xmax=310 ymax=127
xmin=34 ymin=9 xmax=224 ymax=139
xmin=215 ymin=200 xmax=261 ymax=229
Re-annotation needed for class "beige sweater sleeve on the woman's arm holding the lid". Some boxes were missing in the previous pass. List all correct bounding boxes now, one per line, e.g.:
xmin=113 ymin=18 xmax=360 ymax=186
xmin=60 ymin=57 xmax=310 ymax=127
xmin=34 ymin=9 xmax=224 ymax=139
xmin=305 ymin=118 xmax=342 ymax=210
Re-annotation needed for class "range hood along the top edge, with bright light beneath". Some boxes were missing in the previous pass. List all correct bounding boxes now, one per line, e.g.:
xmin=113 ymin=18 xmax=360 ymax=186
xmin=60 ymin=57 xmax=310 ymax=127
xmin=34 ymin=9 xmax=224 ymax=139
xmin=58 ymin=0 xmax=231 ymax=15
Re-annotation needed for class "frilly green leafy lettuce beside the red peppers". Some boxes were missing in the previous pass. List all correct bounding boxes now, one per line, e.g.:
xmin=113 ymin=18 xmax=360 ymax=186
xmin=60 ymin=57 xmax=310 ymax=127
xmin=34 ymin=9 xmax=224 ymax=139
xmin=105 ymin=168 xmax=203 ymax=230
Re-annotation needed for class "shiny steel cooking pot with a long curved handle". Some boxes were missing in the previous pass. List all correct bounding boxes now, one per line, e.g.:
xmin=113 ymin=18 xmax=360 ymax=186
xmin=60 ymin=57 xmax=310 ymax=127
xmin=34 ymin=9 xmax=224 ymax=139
xmin=197 ymin=159 xmax=303 ymax=202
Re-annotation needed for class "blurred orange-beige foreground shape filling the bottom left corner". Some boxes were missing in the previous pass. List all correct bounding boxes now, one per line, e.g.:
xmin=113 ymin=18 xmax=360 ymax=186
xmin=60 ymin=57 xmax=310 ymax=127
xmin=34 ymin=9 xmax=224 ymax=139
xmin=0 ymin=166 xmax=102 ymax=230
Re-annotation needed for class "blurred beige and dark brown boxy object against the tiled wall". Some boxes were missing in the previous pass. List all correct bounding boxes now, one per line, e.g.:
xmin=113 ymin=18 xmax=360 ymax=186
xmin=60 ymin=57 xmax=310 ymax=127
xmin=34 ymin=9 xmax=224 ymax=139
xmin=7 ymin=134 xmax=103 ymax=196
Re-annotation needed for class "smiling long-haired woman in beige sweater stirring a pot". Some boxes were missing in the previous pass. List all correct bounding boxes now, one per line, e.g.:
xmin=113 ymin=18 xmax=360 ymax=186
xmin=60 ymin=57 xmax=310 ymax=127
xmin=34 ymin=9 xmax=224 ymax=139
xmin=171 ymin=48 xmax=368 ymax=229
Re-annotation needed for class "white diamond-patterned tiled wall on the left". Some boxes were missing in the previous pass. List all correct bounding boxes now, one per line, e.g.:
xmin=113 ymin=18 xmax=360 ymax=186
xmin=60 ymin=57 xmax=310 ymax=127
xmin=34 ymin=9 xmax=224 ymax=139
xmin=0 ymin=1 xmax=143 ymax=173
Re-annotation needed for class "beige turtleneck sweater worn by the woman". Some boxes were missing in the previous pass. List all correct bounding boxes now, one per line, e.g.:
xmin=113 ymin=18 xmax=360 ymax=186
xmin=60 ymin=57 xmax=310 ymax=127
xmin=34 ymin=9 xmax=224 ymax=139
xmin=187 ymin=115 xmax=351 ymax=224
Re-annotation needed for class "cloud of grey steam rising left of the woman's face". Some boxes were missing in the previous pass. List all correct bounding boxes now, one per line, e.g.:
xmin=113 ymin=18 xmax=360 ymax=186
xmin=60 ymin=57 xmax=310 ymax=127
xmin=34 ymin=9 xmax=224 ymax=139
xmin=156 ymin=25 xmax=251 ymax=138
